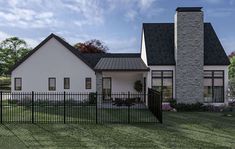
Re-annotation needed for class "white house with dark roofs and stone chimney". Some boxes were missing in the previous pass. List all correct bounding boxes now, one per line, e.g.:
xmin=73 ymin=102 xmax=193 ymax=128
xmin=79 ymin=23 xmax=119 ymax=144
xmin=11 ymin=7 xmax=230 ymax=103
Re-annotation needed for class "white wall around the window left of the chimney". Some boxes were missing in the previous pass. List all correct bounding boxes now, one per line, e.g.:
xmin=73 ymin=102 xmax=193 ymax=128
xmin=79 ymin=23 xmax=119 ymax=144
xmin=146 ymin=66 xmax=175 ymax=98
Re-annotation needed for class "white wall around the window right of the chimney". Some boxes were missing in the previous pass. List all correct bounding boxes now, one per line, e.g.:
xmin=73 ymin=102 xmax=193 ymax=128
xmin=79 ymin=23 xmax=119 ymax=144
xmin=203 ymin=66 xmax=228 ymax=105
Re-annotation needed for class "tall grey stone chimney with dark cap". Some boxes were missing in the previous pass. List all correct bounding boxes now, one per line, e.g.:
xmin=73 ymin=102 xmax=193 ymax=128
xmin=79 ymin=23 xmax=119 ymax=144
xmin=175 ymin=7 xmax=204 ymax=103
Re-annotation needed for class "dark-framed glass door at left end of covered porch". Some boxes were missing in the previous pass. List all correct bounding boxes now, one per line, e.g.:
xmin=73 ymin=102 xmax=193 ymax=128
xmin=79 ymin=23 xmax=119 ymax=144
xmin=102 ymin=77 xmax=112 ymax=101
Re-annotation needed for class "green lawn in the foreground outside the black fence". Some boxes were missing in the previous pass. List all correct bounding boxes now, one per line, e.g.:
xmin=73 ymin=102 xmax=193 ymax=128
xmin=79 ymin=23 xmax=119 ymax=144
xmin=0 ymin=112 xmax=235 ymax=149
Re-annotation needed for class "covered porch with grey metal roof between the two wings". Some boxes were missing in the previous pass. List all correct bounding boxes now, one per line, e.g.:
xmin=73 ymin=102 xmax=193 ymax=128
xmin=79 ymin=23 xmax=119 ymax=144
xmin=95 ymin=57 xmax=149 ymax=101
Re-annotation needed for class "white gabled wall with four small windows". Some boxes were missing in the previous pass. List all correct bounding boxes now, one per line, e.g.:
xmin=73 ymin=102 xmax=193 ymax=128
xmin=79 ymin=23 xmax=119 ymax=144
xmin=11 ymin=38 xmax=96 ymax=92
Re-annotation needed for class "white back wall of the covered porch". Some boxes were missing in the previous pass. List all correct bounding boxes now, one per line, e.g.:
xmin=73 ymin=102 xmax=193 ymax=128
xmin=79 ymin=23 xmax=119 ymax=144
xmin=102 ymin=72 xmax=143 ymax=93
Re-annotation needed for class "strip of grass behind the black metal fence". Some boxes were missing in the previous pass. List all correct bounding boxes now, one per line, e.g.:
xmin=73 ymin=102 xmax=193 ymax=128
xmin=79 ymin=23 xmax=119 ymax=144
xmin=2 ymin=101 xmax=157 ymax=123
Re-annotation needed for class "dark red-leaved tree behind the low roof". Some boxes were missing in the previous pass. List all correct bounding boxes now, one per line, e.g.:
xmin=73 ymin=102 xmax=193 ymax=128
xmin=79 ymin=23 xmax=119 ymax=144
xmin=74 ymin=39 xmax=109 ymax=53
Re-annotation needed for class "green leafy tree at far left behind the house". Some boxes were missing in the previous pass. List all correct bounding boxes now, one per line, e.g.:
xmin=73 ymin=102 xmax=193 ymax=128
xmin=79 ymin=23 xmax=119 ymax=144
xmin=0 ymin=37 xmax=31 ymax=75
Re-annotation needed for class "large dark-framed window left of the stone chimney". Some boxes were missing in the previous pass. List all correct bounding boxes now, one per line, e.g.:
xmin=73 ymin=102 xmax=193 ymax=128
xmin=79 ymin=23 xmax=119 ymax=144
xmin=152 ymin=70 xmax=173 ymax=101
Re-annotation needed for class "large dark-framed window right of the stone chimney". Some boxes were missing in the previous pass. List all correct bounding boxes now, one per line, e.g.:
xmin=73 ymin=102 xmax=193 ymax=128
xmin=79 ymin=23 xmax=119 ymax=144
xmin=204 ymin=70 xmax=224 ymax=103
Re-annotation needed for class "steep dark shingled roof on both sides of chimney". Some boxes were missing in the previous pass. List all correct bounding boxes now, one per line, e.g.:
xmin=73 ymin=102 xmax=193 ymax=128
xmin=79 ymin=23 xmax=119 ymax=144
xmin=143 ymin=23 xmax=230 ymax=65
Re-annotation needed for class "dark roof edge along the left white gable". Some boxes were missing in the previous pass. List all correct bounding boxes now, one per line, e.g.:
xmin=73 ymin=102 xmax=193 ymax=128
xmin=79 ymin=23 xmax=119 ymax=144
xmin=8 ymin=33 xmax=93 ymax=73
